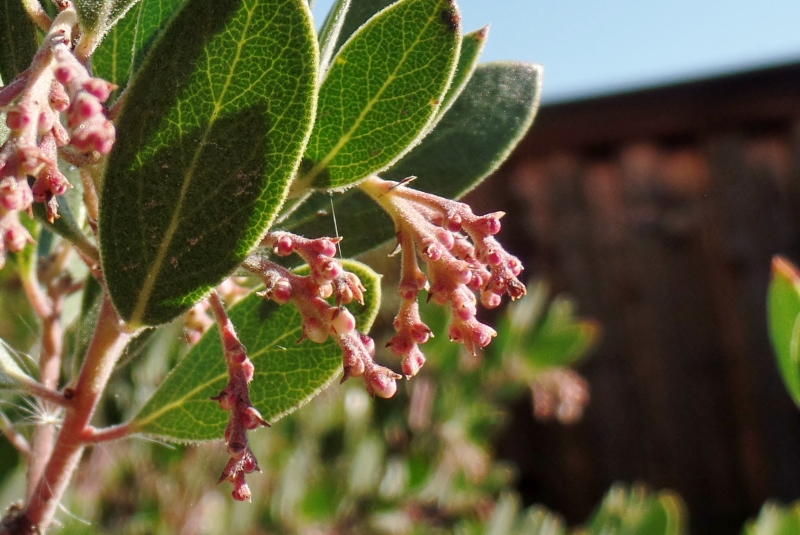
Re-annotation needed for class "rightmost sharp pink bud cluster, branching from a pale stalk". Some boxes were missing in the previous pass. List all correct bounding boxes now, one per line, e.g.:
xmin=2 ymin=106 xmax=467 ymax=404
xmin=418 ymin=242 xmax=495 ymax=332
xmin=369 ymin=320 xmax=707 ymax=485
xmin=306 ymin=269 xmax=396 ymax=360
xmin=361 ymin=177 xmax=525 ymax=376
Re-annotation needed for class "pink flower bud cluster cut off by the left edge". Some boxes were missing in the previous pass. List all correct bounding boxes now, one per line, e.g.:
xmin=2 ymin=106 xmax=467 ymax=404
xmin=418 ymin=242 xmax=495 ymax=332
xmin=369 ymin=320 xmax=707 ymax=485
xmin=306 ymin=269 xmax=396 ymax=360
xmin=0 ymin=10 xmax=116 ymax=267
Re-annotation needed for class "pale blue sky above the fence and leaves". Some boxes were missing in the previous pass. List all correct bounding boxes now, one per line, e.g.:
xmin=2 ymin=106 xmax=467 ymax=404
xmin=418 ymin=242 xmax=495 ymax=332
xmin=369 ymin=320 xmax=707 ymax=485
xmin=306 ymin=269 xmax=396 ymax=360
xmin=315 ymin=0 xmax=800 ymax=102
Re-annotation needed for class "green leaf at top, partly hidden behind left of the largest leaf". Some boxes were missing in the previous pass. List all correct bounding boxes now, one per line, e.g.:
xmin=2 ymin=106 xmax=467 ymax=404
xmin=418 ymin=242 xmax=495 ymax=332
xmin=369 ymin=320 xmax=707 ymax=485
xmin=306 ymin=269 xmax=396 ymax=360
xmin=92 ymin=0 xmax=183 ymax=98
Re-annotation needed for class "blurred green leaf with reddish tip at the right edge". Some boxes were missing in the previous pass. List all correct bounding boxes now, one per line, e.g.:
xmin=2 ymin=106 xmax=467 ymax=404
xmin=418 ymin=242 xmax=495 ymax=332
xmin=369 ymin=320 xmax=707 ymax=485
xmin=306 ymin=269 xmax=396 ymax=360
xmin=767 ymin=256 xmax=800 ymax=406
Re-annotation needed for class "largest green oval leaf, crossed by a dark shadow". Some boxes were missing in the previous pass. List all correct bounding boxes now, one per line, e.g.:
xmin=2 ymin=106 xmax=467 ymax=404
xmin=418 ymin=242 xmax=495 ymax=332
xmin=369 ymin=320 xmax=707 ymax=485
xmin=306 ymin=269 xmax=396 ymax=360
xmin=99 ymin=0 xmax=317 ymax=325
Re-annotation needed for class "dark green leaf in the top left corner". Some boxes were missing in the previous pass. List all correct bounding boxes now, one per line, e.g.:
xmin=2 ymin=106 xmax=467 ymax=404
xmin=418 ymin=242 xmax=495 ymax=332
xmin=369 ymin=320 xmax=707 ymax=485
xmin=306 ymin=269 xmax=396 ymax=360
xmin=0 ymin=0 xmax=39 ymax=82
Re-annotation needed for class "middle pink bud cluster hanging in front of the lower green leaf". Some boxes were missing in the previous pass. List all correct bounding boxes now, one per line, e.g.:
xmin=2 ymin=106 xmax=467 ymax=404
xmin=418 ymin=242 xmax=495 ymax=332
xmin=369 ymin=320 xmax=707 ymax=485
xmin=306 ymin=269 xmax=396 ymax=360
xmin=243 ymin=232 xmax=401 ymax=398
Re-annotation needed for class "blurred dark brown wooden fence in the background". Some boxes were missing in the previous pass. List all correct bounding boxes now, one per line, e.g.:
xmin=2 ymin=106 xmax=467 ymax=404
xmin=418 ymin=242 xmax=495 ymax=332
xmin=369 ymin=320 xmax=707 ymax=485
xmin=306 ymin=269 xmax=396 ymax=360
xmin=472 ymin=64 xmax=800 ymax=533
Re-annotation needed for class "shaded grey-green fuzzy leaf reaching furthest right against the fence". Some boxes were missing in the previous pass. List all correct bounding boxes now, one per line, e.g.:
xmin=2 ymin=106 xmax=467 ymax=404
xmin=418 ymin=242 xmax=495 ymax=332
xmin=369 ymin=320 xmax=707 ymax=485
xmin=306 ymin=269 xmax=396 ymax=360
xmin=279 ymin=62 xmax=542 ymax=256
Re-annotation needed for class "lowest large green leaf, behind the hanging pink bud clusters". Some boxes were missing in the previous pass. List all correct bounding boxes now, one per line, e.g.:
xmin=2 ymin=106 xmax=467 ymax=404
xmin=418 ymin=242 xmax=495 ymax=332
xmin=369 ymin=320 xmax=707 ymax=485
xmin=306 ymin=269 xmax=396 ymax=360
xmin=132 ymin=261 xmax=380 ymax=441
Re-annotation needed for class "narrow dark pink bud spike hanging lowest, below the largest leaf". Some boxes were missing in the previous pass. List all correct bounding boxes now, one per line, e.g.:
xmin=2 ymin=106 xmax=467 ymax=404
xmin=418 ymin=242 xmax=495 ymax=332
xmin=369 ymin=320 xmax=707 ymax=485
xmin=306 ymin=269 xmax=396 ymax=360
xmin=210 ymin=294 xmax=269 ymax=502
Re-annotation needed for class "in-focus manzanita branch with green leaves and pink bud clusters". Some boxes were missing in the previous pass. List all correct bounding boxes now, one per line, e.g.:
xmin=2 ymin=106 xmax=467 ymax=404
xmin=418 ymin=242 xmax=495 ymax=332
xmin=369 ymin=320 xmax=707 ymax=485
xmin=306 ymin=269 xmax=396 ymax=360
xmin=0 ymin=0 xmax=541 ymax=533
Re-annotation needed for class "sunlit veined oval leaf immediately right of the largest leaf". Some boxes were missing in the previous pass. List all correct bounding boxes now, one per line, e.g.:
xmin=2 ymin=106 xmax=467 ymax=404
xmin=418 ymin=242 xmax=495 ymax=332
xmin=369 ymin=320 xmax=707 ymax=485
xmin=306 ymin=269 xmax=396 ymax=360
xmin=298 ymin=0 xmax=461 ymax=189
